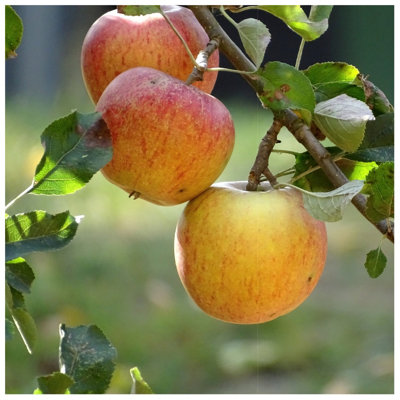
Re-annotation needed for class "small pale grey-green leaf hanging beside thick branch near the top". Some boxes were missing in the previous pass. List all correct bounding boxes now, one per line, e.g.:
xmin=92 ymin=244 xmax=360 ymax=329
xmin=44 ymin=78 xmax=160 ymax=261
xmin=236 ymin=18 xmax=271 ymax=69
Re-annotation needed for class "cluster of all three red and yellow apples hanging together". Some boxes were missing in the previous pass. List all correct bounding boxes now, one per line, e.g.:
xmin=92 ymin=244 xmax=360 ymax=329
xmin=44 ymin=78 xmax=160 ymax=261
xmin=82 ymin=6 xmax=326 ymax=323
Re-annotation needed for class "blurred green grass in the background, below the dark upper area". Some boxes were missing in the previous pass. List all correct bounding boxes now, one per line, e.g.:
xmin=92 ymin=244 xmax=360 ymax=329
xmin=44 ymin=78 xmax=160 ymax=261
xmin=6 ymin=102 xmax=394 ymax=393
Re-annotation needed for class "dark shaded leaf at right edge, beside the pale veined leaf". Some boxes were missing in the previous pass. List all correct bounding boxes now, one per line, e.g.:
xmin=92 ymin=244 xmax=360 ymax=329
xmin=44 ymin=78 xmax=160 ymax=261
xmin=348 ymin=113 xmax=394 ymax=162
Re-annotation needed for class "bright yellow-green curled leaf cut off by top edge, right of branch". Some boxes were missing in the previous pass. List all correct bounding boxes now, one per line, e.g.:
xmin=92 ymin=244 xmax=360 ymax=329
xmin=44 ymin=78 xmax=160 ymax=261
xmin=257 ymin=5 xmax=333 ymax=41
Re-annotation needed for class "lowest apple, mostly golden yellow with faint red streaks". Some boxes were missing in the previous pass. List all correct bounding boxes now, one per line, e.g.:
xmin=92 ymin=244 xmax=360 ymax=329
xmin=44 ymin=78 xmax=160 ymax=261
xmin=175 ymin=182 xmax=327 ymax=324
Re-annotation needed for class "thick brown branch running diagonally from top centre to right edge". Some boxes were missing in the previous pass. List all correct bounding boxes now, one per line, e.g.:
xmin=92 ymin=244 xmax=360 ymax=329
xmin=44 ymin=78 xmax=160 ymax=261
xmin=188 ymin=6 xmax=394 ymax=242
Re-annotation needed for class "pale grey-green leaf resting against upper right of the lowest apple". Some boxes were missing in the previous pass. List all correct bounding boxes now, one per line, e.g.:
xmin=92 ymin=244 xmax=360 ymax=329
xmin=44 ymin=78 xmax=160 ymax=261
xmin=288 ymin=180 xmax=364 ymax=222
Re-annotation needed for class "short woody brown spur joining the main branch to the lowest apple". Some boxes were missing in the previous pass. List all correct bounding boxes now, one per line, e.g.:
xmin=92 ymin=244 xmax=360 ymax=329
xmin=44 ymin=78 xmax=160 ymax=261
xmin=246 ymin=118 xmax=282 ymax=191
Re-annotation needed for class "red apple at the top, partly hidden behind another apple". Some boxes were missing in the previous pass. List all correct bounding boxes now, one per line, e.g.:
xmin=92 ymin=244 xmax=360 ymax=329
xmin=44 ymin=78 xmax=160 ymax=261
xmin=81 ymin=5 xmax=219 ymax=104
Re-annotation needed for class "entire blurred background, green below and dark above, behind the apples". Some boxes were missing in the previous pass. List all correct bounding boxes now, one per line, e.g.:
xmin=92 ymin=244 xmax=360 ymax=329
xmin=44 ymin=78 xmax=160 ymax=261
xmin=5 ymin=6 xmax=394 ymax=394
